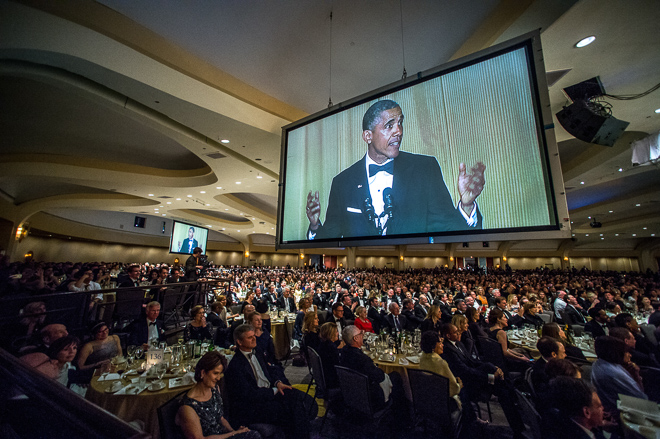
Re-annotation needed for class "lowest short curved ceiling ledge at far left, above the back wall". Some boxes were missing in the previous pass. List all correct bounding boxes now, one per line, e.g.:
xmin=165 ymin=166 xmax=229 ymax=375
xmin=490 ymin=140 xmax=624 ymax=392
xmin=14 ymin=193 xmax=159 ymax=224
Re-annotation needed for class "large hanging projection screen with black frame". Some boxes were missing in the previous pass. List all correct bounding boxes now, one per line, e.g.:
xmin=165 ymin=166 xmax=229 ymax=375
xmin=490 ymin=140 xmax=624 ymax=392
xmin=277 ymin=34 xmax=570 ymax=248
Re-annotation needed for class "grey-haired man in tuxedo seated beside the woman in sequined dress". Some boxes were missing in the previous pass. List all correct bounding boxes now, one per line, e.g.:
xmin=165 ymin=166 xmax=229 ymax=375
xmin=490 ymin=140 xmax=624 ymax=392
xmin=225 ymin=325 xmax=318 ymax=438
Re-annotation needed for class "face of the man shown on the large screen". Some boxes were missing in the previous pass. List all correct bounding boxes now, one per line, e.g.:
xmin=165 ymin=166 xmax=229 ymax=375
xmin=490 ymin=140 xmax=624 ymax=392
xmin=363 ymin=107 xmax=403 ymax=163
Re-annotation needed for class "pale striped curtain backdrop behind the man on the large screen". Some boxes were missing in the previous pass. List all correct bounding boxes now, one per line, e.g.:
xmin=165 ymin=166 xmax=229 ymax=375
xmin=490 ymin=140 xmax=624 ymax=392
xmin=283 ymin=48 xmax=553 ymax=241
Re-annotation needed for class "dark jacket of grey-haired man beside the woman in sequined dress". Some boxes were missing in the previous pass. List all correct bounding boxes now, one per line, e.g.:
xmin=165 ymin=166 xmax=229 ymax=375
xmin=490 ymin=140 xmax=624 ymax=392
xmin=225 ymin=347 xmax=288 ymax=425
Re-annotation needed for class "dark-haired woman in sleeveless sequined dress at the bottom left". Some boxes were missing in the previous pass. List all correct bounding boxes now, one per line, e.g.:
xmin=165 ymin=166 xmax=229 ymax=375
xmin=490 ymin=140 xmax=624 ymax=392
xmin=175 ymin=351 xmax=261 ymax=439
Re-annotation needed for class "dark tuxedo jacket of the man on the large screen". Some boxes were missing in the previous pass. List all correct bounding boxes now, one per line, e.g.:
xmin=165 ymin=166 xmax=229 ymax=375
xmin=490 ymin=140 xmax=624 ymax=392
xmin=316 ymin=151 xmax=481 ymax=239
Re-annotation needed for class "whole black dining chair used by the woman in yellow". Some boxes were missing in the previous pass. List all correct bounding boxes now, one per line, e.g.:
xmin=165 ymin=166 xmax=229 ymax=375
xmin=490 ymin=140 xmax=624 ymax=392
xmin=408 ymin=369 xmax=461 ymax=438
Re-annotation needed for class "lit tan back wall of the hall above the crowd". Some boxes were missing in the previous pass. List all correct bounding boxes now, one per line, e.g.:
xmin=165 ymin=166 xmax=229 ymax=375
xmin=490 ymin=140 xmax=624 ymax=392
xmin=18 ymin=236 xmax=640 ymax=271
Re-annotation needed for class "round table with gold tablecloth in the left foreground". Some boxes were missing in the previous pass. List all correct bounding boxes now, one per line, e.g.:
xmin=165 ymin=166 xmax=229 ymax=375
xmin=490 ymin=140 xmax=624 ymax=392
xmin=85 ymin=375 xmax=192 ymax=439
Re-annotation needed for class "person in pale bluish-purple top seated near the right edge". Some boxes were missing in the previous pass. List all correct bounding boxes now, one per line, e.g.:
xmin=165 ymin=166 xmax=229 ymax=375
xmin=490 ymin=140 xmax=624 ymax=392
xmin=591 ymin=335 xmax=648 ymax=414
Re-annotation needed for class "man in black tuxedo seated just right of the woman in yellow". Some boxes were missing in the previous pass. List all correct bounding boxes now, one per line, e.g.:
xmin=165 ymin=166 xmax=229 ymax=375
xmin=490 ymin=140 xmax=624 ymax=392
xmin=441 ymin=323 xmax=525 ymax=439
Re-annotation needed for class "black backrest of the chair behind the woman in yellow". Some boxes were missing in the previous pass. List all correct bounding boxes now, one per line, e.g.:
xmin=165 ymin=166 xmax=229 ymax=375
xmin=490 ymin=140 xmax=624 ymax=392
xmin=408 ymin=369 xmax=451 ymax=426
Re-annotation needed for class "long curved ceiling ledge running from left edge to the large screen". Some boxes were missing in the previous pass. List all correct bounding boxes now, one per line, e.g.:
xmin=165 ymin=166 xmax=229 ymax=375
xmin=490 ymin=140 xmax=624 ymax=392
xmin=0 ymin=60 xmax=279 ymax=180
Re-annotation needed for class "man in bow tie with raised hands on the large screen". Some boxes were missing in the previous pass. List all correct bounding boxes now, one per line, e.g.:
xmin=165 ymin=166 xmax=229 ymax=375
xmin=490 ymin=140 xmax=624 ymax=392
xmin=306 ymin=100 xmax=486 ymax=239
